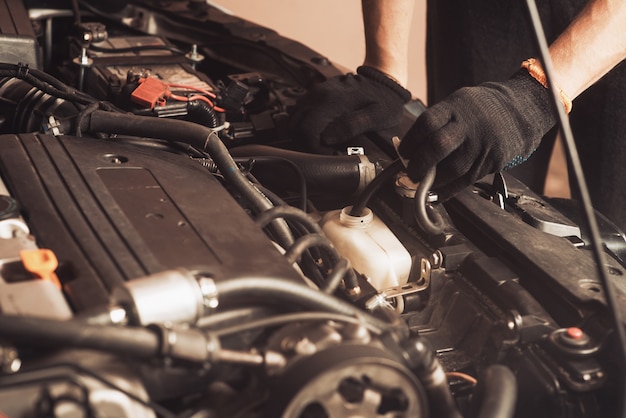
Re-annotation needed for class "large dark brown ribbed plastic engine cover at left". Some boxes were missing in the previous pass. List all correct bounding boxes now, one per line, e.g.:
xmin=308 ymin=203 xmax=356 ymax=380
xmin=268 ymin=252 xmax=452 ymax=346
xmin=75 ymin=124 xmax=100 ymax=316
xmin=0 ymin=134 xmax=298 ymax=310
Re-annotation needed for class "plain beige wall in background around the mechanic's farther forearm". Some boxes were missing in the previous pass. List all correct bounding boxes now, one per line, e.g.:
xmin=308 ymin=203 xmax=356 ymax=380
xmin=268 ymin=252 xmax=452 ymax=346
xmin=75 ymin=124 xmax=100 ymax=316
xmin=209 ymin=0 xmax=426 ymax=101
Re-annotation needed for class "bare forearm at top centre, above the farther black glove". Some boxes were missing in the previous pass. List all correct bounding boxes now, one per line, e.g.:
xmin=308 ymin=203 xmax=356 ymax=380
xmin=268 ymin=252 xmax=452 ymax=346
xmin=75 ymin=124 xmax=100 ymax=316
xmin=362 ymin=0 xmax=415 ymax=86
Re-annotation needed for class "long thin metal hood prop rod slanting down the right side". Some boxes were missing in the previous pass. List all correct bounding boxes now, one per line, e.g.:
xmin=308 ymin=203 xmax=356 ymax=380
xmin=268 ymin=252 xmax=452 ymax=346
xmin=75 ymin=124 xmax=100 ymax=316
xmin=526 ymin=0 xmax=626 ymax=416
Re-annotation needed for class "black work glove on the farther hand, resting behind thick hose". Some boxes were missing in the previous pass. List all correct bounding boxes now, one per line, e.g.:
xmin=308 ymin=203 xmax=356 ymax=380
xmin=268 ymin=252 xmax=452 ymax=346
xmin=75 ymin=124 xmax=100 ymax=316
xmin=290 ymin=66 xmax=411 ymax=154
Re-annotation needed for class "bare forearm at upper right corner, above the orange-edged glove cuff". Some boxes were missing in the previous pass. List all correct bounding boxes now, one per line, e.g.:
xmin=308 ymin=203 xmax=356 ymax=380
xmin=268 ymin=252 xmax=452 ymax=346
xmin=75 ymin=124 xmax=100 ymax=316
xmin=550 ymin=0 xmax=626 ymax=99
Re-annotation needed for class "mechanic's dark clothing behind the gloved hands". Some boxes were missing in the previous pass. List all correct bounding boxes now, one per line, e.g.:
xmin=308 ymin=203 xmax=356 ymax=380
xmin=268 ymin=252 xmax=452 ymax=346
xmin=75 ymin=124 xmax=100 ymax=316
xmin=426 ymin=0 xmax=626 ymax=230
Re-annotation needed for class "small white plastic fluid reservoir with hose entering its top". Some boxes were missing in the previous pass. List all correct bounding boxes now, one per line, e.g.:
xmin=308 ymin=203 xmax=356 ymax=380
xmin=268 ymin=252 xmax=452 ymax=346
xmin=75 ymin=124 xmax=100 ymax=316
xmin=320 ymin=206 xmax=411 ymax=291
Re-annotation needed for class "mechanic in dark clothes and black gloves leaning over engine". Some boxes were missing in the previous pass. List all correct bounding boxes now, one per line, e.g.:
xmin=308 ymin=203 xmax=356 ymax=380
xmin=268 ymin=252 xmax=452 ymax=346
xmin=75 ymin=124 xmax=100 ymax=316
xmin=293 ymin=0 xmax=626 ymax=230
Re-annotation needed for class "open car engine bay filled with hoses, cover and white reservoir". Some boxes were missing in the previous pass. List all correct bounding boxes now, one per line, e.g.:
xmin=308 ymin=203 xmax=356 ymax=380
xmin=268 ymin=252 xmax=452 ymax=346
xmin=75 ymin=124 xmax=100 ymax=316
xmin=0 ymin=0 xmax=626 ymax=418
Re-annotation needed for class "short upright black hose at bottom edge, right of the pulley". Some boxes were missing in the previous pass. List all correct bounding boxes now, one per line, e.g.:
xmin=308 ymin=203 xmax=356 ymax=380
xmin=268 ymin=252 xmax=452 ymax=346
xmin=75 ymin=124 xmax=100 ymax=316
xmin=476 ymin=364 xmax=517 ymax=418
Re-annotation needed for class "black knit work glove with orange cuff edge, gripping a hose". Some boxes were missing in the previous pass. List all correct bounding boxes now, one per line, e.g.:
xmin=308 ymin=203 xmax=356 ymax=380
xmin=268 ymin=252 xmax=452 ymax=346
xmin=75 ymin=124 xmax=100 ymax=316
xmin=398 ymin=70 xmax=556 ymax=200
